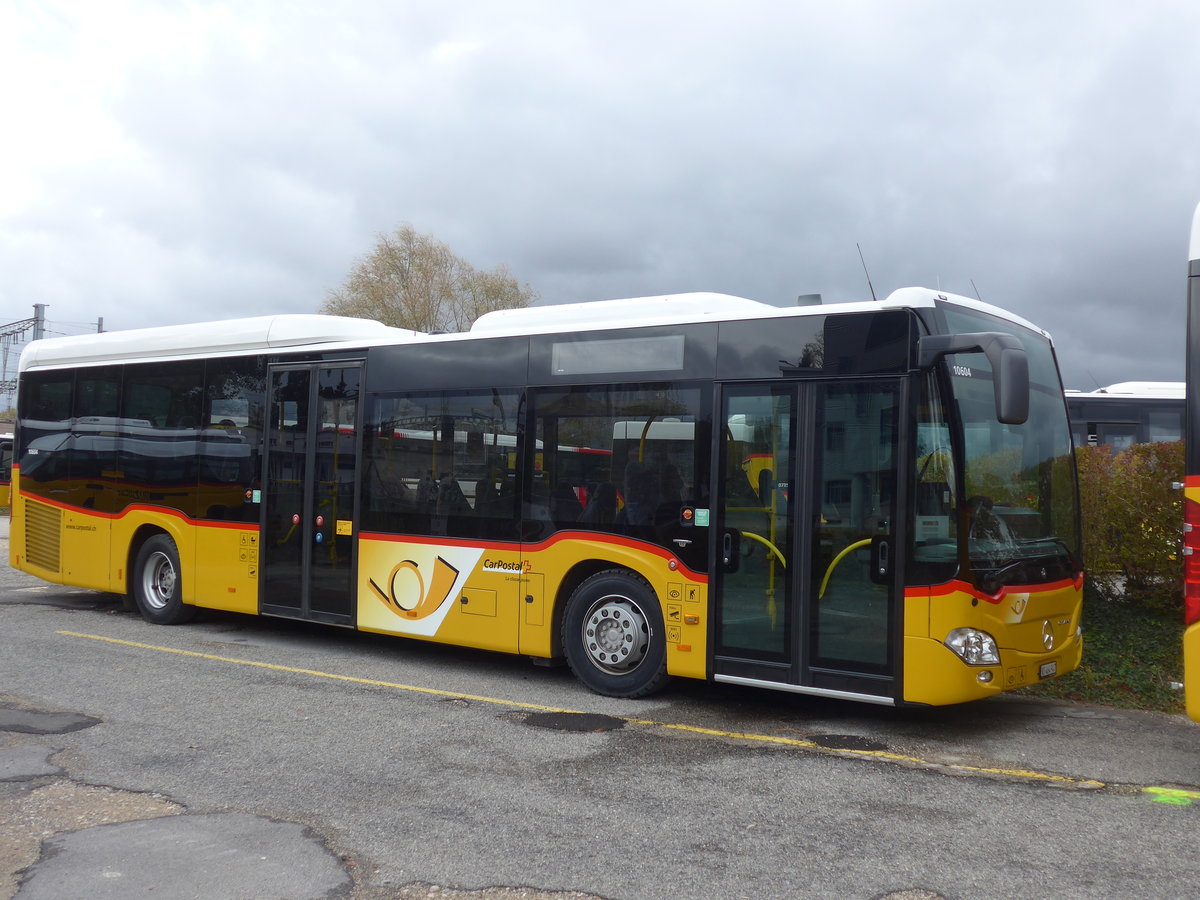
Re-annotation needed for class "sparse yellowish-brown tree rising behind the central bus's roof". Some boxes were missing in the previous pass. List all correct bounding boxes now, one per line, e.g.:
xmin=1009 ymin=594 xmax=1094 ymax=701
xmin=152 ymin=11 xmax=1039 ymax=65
xmin=320 ymin=224 xmax=538 ymax=331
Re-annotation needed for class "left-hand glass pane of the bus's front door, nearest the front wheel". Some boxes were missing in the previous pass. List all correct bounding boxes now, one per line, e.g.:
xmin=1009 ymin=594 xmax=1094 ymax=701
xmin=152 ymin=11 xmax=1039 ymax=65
xmin=718 ymin=388 xmax=796 ymax=661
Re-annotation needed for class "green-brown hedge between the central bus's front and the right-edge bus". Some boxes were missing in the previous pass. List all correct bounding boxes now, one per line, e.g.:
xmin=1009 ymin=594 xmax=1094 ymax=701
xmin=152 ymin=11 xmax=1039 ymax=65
xmin=1075 ymin=442 xmax=1183 ymax=613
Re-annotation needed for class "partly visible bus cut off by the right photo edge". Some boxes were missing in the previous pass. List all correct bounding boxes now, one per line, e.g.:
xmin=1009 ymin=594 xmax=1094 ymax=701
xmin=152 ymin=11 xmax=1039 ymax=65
xmin=1183 ymin=205 xmax=1200 ymax=722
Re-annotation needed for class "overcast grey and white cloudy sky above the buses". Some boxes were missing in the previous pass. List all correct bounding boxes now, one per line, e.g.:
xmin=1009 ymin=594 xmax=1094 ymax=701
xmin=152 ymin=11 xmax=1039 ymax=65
xmin=0 ymin=0 xmax=1200 ymax=389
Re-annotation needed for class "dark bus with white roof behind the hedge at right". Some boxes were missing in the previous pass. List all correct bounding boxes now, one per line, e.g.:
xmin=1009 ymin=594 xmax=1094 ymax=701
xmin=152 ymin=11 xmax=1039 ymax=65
xmin=1066 ymin=382 xmax=1184 ymax=454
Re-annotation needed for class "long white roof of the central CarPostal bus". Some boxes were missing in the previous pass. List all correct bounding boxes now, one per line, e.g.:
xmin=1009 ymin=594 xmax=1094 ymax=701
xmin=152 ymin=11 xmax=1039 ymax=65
xmin=19 ymin=288 xmax=1050 ymax=372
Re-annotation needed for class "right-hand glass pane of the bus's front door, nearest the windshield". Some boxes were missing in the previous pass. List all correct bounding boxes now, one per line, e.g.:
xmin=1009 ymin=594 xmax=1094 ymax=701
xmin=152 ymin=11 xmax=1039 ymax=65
xmin=809 ymin=384 xmax=899 ymax=673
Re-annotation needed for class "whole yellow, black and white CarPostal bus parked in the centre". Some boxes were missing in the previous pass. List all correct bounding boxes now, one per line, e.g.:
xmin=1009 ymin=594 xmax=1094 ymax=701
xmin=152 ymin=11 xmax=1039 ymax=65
xmin=11 ymin=288 xmax=1084 ymax=704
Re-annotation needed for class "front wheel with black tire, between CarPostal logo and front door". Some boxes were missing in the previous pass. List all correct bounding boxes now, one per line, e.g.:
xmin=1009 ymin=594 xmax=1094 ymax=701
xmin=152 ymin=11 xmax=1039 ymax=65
xmin=563 ymin=569 xmax=671 ymax=697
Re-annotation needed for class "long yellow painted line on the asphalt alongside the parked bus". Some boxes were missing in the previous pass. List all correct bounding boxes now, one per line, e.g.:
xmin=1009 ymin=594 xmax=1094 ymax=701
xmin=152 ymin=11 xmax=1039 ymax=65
xmin=56 ymin=631 xmax=1099 ymax=799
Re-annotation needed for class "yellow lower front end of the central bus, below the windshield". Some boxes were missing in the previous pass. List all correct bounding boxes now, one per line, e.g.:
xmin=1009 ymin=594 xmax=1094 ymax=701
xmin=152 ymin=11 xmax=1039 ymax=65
xmin=904 ymin=582 xmax=1082 ymax=704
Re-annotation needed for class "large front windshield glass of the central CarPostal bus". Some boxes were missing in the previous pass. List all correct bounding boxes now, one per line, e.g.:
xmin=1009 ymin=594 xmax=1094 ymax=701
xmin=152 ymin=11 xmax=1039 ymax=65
xmin=942 ymin=305 xmax=1080 ymax=594
